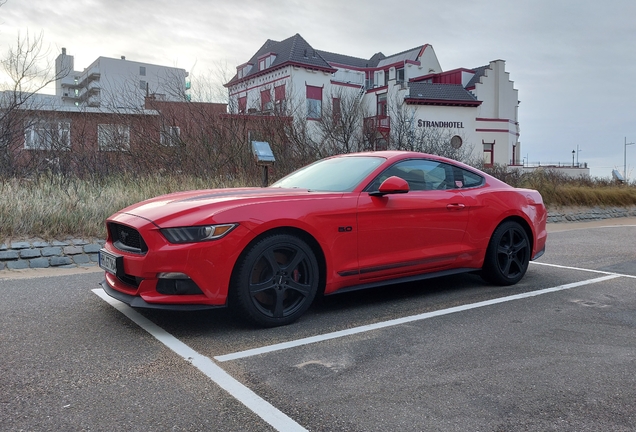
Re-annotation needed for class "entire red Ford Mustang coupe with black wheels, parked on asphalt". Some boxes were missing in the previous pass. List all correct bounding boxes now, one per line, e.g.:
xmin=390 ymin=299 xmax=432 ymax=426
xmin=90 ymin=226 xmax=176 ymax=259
xmin=99 ymin=151 xmax=547 ymax=326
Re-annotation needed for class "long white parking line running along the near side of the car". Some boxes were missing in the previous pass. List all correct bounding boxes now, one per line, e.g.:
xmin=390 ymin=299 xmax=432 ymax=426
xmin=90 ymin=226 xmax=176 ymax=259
xmin=214 ymin=274 xmax=623 ymax=362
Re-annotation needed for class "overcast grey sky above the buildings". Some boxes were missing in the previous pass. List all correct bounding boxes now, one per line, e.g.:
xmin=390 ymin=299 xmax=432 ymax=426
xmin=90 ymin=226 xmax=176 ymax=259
xmin=0 ymin=0 xmax=636 ymax=178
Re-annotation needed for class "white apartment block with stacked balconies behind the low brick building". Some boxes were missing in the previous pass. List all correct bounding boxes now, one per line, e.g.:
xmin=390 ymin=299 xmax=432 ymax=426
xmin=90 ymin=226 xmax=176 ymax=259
xmin=55 ymin=48 xmax=189 ymax=109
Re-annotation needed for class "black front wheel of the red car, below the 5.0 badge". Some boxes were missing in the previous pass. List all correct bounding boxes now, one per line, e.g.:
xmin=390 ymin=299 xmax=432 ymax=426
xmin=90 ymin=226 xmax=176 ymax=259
xmin=230 ymin=234 xmax=319 ymax=327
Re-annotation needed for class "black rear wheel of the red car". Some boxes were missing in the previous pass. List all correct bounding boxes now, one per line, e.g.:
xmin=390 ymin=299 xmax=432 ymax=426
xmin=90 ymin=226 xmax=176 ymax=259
xmin=482 ymin=221 xmax=531 ymax=285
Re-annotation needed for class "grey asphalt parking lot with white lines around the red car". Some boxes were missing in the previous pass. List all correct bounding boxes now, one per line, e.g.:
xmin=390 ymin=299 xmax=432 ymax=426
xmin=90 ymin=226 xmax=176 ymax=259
xmin=0 ymin=219 xmax=636 ymax=431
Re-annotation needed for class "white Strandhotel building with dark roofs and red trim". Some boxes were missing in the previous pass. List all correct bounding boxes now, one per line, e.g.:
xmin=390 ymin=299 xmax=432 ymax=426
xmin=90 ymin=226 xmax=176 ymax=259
xmin=226 ymin=34 xmax=522 ymax=165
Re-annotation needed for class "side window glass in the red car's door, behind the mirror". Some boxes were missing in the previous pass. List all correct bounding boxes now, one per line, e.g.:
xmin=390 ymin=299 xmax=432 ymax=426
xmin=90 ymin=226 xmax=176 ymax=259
xmin=366 ymin=159 xmax=460 ymax=191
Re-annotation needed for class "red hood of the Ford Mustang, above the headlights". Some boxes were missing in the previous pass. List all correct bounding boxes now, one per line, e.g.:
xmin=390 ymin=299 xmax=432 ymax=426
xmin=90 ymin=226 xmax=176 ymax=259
xmin=119 ymin=188 xmax=330 ymax=228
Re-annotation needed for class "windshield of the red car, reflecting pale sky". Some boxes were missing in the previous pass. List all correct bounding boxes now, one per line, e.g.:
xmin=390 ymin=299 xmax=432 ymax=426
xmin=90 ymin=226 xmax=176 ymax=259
xmin=271 ymin=156 xmax=385 ymax=192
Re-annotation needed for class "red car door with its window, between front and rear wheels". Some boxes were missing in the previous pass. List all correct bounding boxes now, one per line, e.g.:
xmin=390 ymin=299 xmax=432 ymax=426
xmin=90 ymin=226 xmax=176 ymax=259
xmin=358 ymin=159 xmax=469 ymax=280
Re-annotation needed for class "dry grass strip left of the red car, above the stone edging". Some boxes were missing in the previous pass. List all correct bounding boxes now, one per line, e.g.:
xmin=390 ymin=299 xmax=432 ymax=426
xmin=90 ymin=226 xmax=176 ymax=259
xmin=0 ymin=176 xmax=253 ymax=243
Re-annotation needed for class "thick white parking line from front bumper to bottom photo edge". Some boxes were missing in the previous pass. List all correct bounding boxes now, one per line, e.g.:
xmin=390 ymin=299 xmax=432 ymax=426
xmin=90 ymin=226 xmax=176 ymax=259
xmin=93 ymin=288 xmax=307 ymax=432
